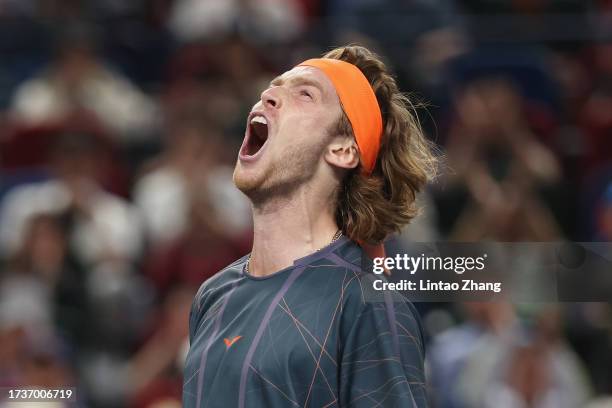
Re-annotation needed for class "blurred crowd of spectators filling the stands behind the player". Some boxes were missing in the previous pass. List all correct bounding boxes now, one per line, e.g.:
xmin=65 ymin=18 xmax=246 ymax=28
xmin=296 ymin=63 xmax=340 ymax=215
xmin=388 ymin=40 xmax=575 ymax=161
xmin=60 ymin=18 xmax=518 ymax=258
xmin=0 ymin=0 xmax=612 ymax=408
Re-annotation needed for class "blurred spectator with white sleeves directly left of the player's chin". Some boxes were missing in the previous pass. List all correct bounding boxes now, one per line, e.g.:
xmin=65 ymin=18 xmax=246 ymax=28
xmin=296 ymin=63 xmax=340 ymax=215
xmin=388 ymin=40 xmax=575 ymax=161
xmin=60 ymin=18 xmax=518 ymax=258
xmin=134 ymin=111 xmax=251 ymax=298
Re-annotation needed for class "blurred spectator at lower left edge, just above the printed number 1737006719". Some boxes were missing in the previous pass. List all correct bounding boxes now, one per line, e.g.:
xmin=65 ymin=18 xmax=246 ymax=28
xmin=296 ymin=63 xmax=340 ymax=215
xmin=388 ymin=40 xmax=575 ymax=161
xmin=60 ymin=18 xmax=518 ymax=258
xmin=0 ymin=215 xmax=78 ymax=402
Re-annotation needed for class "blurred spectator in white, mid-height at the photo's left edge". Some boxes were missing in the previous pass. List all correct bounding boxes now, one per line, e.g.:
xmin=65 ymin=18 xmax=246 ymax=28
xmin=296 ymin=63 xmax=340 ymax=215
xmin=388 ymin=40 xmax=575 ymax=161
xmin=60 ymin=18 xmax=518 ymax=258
xmin=0 ymin=133 xmax=142 ymax=265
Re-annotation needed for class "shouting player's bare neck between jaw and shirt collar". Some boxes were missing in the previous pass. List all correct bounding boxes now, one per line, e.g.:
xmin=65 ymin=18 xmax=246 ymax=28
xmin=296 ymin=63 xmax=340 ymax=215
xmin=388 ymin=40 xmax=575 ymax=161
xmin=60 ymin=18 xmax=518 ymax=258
xmin=249 ymin=186 xmax=338 ymax=276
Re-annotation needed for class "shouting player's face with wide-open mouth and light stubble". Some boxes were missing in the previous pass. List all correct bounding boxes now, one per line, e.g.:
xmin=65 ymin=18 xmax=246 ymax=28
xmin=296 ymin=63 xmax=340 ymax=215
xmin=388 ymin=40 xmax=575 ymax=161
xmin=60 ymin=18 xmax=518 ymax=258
xmin=234 ymin=67 xmax=342 ymax=201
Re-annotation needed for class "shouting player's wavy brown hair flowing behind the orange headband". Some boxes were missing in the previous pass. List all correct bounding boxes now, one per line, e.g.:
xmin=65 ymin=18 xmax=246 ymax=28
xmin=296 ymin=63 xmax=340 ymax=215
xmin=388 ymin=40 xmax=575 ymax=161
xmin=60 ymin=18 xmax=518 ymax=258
xmin=323 ymin=45 xmax=437 ymax=244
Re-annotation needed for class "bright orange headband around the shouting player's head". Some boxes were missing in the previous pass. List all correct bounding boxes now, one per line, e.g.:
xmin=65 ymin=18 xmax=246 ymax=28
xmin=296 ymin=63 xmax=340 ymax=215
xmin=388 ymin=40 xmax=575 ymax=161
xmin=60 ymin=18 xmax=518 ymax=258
xmin=298 ymin=58 xmax=382 ymax=175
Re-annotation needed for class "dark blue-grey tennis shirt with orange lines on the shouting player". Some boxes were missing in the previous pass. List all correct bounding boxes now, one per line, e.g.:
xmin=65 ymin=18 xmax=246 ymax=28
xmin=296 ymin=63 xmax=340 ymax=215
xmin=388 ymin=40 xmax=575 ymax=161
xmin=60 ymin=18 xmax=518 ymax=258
xmin=183 ymin=236 xmax=427 ymax=408
